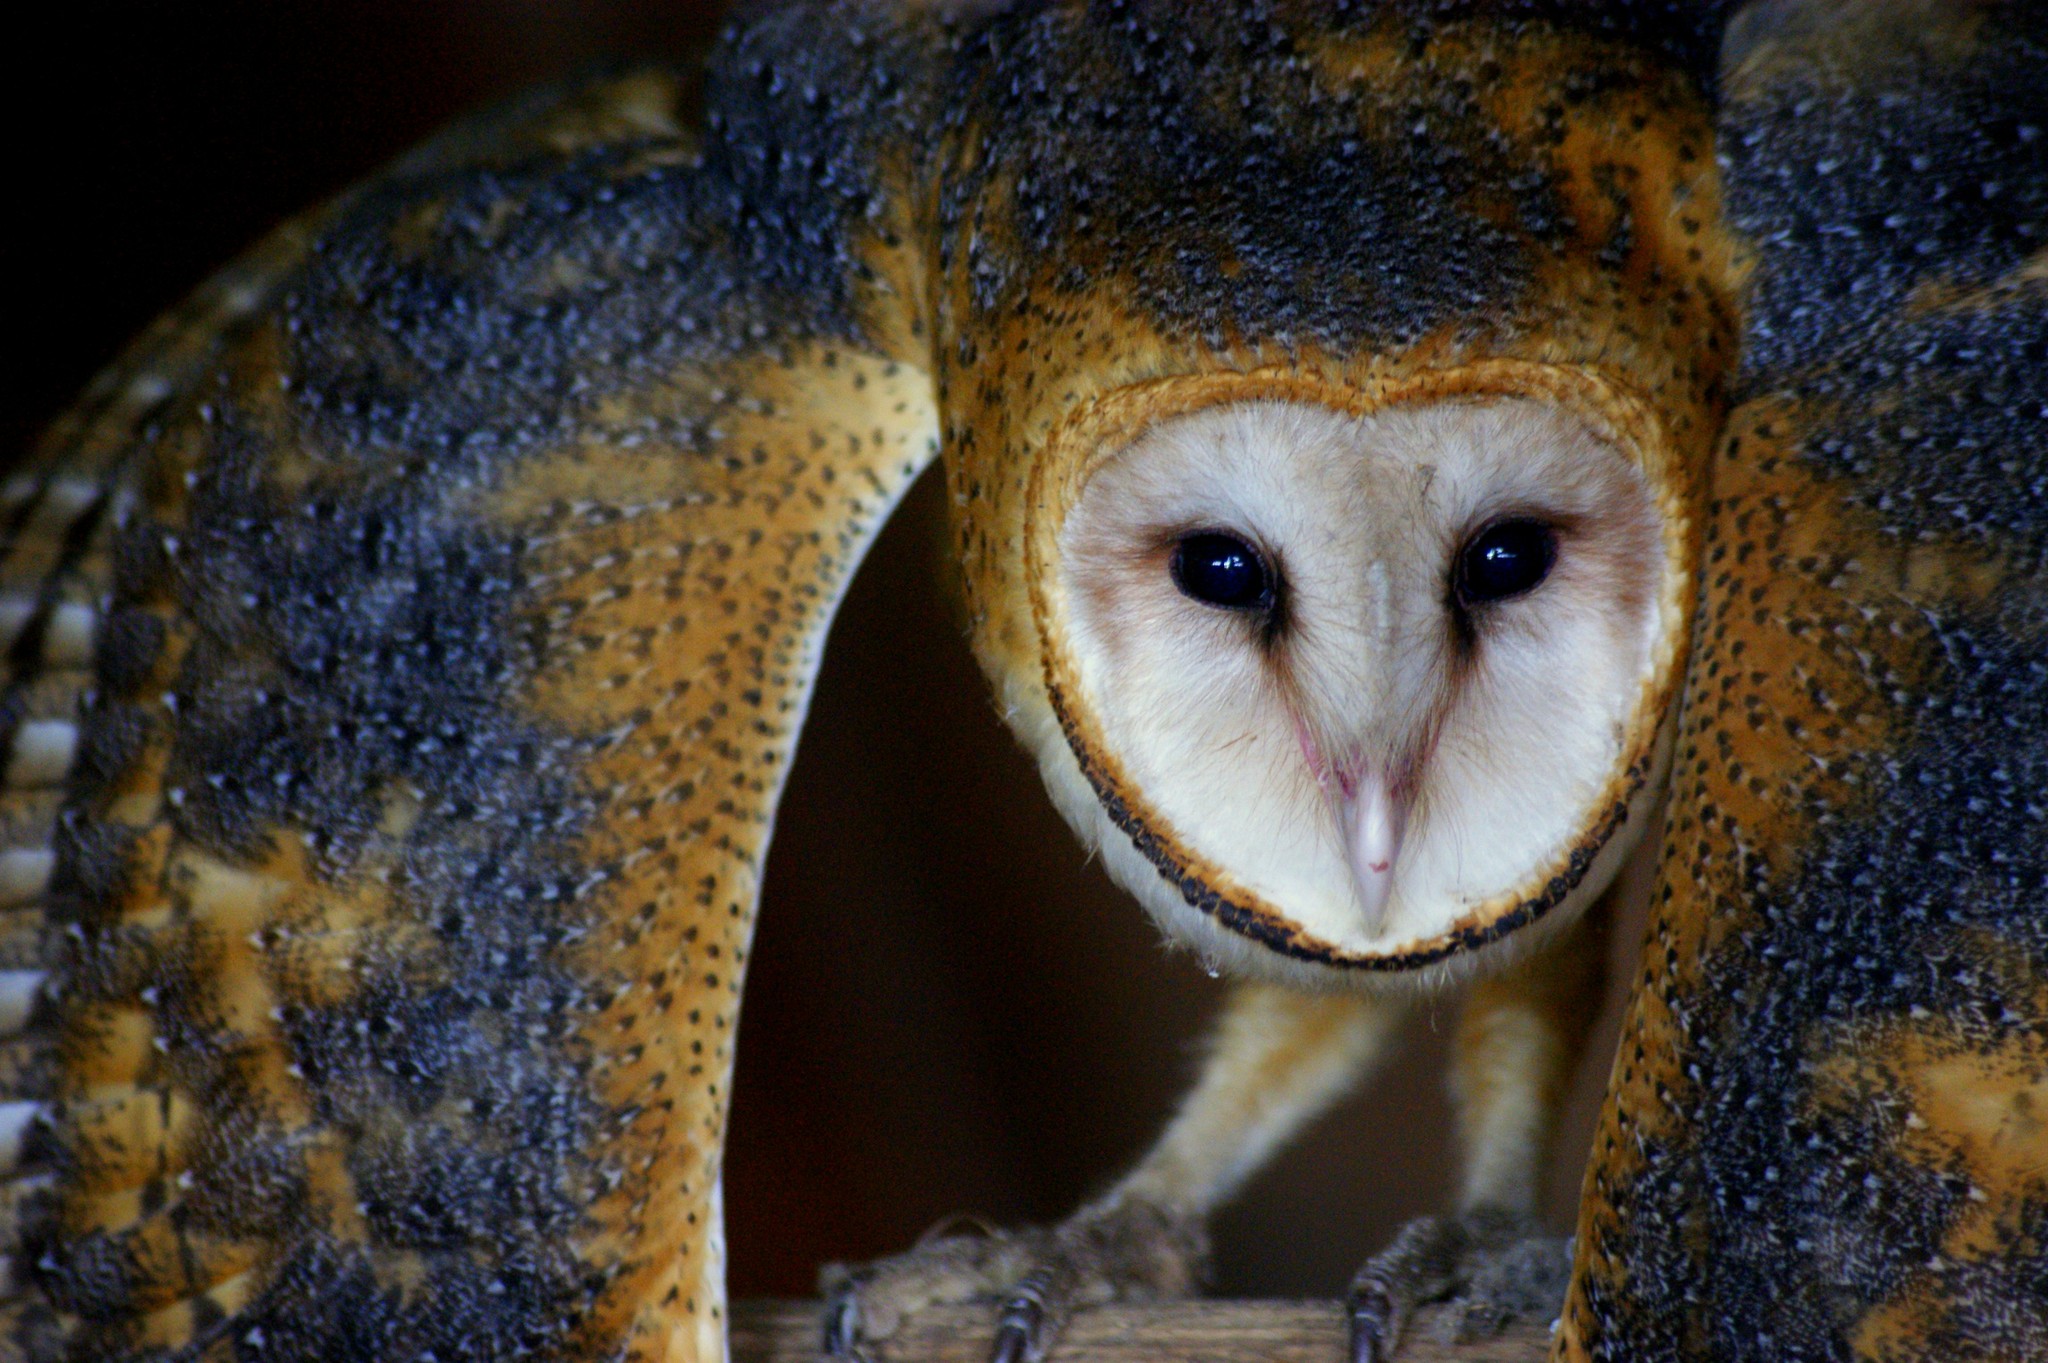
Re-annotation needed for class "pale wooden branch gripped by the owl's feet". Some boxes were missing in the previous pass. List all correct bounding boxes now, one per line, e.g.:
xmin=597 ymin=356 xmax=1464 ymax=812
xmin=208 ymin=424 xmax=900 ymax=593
xmin=731 ymin=1302 xmax=1550 ymax=1363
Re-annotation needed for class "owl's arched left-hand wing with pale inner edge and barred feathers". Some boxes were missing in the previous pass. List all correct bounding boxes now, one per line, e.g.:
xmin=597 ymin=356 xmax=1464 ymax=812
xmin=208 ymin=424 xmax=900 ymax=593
xmin=0 ymin=12 xmax=940 ymax=1359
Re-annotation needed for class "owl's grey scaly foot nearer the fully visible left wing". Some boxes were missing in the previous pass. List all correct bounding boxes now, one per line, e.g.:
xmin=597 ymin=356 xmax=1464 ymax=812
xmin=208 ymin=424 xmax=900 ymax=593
xmin=821 ymin=1201 xmax=1208 ymax=1363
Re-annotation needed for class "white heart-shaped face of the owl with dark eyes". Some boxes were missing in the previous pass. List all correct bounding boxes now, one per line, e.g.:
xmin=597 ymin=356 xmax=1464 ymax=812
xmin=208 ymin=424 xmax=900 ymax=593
xmin=1032 ymin=366 xmax=1690 ymax=974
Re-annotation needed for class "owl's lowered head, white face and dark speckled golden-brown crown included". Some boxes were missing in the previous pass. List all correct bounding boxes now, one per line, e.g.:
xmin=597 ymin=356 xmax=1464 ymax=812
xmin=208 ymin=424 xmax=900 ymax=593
xmin=936 ymin=4 xmax=1735 ymax=982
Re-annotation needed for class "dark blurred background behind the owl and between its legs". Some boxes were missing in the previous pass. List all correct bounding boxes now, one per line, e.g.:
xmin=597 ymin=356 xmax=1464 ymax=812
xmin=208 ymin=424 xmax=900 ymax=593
xmin=16 ymin=0 xmax=1640 ymax=1295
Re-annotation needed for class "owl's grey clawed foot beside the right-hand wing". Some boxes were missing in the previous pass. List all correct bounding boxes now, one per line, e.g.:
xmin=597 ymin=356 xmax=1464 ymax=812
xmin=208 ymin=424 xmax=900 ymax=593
xmin=1350 ymin=1212 xmax=1571 ymax=1363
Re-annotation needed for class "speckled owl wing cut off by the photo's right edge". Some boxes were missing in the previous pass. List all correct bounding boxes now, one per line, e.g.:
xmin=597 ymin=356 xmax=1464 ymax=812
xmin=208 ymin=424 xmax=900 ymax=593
xmin=1559 ymin=2 xmax=2048 ymax=1363
